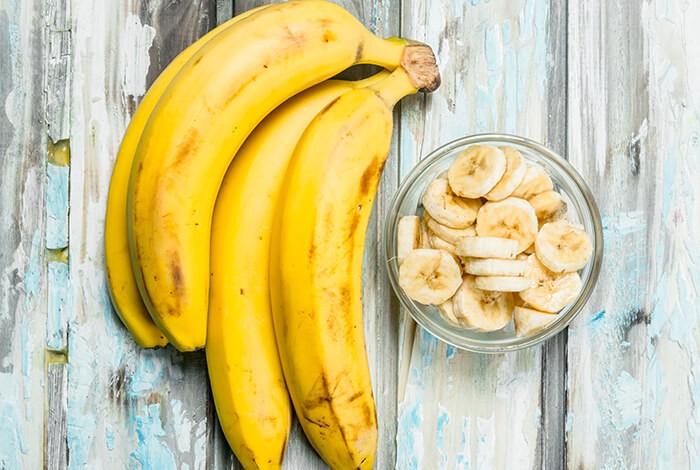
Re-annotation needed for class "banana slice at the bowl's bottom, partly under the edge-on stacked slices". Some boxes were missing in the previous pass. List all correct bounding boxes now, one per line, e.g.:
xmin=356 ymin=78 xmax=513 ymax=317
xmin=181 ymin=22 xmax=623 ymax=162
xmin=452 ymin=276 xmax=515 ymax=331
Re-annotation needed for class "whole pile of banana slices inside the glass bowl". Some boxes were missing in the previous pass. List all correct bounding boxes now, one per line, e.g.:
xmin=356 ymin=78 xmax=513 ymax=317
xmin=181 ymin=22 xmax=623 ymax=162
xmin=397 ymin=145 xmax=593 ymax=336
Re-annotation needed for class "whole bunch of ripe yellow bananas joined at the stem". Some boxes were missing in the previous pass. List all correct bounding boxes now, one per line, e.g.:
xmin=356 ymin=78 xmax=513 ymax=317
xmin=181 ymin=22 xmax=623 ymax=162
xmin=105 ymin=0 xmax=440 ymax=469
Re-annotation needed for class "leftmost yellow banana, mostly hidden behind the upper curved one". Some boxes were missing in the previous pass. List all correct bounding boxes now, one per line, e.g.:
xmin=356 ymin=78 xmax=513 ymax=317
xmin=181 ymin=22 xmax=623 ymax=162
xmin=105 ymin=6 xmax=265 ymax=348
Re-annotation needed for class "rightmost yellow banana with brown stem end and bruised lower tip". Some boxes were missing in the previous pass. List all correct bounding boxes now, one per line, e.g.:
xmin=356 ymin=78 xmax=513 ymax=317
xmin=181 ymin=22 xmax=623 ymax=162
xmin=270 ymin=47 xmax=439 ymax=469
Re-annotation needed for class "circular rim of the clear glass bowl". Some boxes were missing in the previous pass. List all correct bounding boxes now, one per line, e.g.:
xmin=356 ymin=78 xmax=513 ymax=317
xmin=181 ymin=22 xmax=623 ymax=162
xmin=382 ymin=133 xmax=604 ymax=354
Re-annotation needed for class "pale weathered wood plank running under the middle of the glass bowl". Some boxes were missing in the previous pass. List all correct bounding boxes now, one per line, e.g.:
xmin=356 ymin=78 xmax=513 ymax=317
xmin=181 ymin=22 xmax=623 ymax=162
xmin=397 ymin=0 xmax=564 ymax=469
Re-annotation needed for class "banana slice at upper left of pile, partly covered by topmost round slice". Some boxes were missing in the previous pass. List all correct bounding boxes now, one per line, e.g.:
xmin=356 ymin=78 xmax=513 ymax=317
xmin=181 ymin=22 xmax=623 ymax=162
xmin=421 ymin=178 xmax=481 ymax=228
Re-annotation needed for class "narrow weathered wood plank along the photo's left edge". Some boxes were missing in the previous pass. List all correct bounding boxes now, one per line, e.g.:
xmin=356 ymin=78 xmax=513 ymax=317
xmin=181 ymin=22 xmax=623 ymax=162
xmin=0 ymin=0 xmax=47 ymax=468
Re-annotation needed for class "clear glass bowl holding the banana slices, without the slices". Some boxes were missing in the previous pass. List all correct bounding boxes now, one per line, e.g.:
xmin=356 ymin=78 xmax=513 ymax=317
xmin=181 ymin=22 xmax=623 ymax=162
xmin=383 ymin=134 xmax=603 ymax=353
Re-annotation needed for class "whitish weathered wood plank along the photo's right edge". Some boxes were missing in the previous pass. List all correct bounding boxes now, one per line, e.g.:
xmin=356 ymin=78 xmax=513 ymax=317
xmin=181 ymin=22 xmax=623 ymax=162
xmin=567 ymin=0 xmax=700 ymax=468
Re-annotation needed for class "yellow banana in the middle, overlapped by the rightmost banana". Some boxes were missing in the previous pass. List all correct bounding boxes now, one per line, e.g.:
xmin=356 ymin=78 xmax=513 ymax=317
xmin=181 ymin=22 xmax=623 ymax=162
xmin=206 ymin=72 xmax=388 ymax=469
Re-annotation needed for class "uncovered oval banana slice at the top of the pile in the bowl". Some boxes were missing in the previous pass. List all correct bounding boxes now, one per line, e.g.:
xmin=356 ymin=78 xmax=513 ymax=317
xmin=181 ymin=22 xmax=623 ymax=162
xmin=447 ymin=145 xmax=506 ymax=198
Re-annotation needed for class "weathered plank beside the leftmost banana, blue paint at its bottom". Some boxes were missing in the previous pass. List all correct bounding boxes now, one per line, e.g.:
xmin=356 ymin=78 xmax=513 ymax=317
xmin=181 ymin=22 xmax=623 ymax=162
xmin=67 ymin=0 xmax=215 ymax=469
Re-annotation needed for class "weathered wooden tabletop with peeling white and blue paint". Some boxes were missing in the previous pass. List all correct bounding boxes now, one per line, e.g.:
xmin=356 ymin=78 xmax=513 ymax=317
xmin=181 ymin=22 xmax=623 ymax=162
xmin=0 ymin=0 xmax=700 ymax=470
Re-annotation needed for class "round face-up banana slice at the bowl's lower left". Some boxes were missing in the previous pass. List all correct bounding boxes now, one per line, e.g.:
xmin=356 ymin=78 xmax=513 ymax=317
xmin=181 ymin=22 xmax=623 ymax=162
xmin=399 ymin=248 xmax=462 ymax=305
